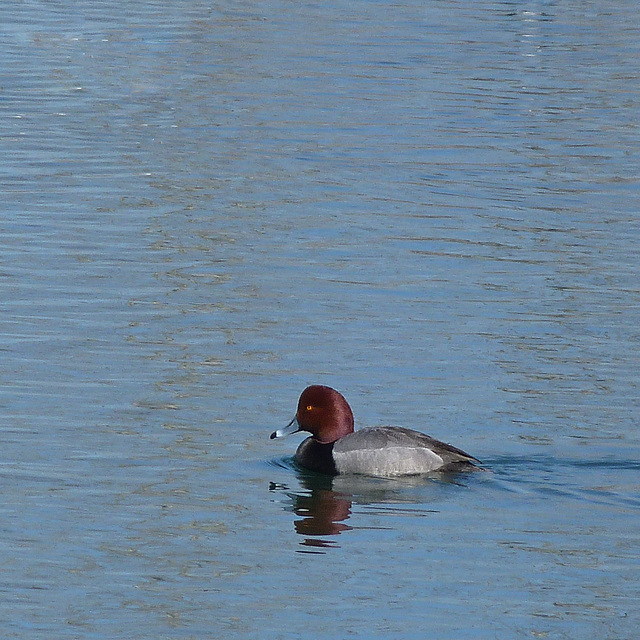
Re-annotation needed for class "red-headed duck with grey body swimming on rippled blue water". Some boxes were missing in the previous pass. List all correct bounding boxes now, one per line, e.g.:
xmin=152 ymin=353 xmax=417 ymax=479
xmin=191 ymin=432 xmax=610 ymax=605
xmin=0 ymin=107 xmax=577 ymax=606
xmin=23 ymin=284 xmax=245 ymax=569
xmin=270 ymin=384 xmax=480 ymax=477
